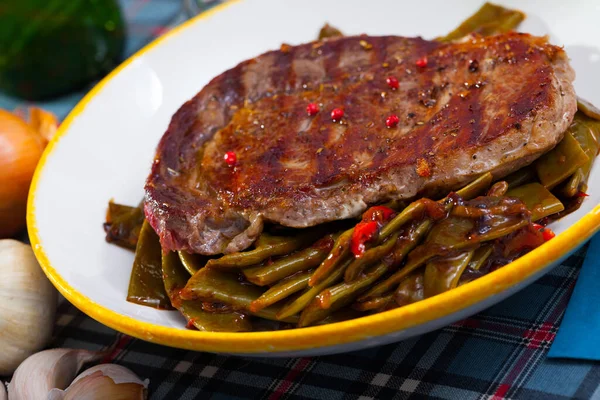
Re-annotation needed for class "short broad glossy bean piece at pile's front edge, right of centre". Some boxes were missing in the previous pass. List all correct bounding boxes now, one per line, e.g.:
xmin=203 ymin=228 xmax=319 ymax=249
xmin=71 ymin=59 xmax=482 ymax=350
xmin=423 ymin=250 xmax=474 ymax=298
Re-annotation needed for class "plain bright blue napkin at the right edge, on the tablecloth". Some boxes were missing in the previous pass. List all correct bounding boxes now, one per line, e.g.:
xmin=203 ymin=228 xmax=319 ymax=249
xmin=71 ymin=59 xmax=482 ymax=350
xmin=548 ymin=234 xmax=600 ymax=360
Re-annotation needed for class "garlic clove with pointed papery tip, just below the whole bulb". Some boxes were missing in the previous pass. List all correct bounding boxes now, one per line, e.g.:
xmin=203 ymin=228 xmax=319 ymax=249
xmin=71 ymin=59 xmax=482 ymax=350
xmin=8 ymin=349 xmax=105 ymax=400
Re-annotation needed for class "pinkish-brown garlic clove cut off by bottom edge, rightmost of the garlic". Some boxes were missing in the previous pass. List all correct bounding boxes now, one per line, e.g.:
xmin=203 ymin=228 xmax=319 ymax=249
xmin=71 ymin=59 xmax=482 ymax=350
xmin=48 ymin=364 xmax=148 ymax=400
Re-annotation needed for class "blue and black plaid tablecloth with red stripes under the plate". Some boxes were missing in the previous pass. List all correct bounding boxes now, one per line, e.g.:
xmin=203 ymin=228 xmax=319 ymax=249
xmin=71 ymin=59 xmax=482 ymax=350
xmin=0 ymin=0 xmax=600 ymax=400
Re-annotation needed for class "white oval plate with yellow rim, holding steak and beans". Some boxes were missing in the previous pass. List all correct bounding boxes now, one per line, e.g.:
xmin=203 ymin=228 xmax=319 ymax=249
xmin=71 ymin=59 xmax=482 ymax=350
xmin=28 ymin=0 xmax=600 ymax=356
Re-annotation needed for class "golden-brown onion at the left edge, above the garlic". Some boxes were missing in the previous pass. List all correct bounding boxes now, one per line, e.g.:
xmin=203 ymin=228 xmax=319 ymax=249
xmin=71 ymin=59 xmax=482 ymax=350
xmin=0 ymin=109 xmax=44 ymax=238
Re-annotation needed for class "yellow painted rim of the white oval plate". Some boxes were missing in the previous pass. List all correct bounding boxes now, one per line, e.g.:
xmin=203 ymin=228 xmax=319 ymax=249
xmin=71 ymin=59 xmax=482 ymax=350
xmin=27 ymin=0 xmax=600 ymax=354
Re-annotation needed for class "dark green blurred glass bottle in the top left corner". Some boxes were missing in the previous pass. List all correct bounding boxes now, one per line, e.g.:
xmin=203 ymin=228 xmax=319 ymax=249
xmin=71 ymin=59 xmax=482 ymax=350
xmin=0 ymin=0 xmax=125 ymax=100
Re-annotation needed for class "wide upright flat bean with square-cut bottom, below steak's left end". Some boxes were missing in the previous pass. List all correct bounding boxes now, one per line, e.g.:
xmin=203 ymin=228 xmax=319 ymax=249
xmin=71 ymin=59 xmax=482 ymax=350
xmin=127 ymin=221 xmax=172 ymax=309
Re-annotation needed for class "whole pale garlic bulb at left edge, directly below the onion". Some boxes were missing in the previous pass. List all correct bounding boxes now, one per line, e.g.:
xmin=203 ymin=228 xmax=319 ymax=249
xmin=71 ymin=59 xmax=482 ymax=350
xmin=0 ymin=239 xmax=57 ymax=375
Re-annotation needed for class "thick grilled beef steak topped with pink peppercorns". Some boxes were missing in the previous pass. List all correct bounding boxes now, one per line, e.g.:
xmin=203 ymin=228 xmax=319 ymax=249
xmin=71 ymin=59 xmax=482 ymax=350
xmin=145 ymin=33 xmax=576 ymax=254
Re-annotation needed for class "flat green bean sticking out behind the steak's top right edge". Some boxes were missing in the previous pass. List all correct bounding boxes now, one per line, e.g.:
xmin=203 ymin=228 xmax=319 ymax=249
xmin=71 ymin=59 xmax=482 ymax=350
xmin=436 ymin=3 xmax=525 ymax=42
